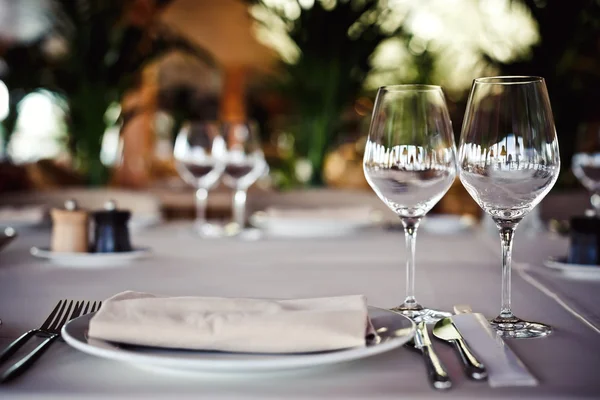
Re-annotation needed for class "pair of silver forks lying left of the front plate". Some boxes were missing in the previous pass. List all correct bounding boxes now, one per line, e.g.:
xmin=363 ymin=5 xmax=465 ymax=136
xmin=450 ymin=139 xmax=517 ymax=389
xmin=0 ymin=300 xmax=102 ymax=383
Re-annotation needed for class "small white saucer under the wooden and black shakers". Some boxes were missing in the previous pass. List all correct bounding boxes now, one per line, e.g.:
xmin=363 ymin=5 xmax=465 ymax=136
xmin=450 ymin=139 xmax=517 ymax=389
xmin=31 ymin=247 xmax=151 ymax=268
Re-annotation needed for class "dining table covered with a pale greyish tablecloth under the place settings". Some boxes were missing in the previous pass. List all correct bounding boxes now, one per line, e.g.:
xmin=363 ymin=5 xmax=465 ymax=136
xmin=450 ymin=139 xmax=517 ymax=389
xmin=0 ymin=222 xmax=600 ymax=400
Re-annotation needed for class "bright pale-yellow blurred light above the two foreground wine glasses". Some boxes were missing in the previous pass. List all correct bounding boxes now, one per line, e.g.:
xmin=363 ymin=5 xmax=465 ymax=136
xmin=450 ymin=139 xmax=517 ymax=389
xmin=365 ymin=0 xmax=540 ymax=94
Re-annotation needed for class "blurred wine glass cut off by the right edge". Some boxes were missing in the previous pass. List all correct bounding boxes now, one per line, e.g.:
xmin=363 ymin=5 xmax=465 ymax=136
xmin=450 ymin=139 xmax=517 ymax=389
xmin=571 ymin=123 xmax=600 ymax=217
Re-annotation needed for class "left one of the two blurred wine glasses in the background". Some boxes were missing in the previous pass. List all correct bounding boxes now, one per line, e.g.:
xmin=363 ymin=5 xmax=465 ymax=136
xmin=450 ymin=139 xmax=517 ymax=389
xmin=173 ymin=121 xmax=226 ymax=237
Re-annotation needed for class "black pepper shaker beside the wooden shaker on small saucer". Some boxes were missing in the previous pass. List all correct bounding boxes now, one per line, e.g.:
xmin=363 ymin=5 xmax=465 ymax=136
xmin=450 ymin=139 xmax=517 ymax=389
xmin=93 ymin=200 xmax=132 ymax=253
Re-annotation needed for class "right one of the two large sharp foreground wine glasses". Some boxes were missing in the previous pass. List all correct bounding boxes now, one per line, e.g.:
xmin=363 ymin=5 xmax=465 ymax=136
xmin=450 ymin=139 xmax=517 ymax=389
xmin=458 ymin=76 xmax=560 ymax=338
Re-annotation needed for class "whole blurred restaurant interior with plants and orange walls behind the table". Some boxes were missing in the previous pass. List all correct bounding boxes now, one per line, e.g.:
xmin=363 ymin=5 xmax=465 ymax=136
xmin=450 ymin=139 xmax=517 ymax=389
xmin=0 ymin=0 xmax=600 ymax=225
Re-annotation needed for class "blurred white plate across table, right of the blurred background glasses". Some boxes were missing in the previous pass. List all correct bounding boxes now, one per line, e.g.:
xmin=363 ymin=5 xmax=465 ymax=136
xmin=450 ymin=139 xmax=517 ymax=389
xmin=250 ymin=212 xmax=378 ymax=238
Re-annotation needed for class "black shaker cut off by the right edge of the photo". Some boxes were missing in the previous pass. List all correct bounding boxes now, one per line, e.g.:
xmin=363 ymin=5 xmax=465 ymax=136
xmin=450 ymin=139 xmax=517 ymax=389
xmin=568 ymin=217 xmax=600 ymax=265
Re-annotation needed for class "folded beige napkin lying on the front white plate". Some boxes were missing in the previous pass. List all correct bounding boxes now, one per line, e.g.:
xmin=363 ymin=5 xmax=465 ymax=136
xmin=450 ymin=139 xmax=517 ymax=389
xmin=88 ymin=292 xmax=373 ymax=353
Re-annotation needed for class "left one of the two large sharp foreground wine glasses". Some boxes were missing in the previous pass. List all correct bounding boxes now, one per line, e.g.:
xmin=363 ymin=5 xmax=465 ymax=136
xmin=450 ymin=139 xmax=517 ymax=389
xmin=363 ymin=85 xmax=456 ymax=323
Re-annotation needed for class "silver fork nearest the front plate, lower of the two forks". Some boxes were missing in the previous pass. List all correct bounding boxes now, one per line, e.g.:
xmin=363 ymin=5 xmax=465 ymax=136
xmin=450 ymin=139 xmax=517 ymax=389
xmin=0 ymin=300 xmax=102 ymax=383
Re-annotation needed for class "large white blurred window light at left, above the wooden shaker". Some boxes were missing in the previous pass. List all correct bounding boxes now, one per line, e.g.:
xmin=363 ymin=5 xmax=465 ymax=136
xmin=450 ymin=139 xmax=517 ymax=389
xmin=8 ymin=91 xmax=67 ymax=163
